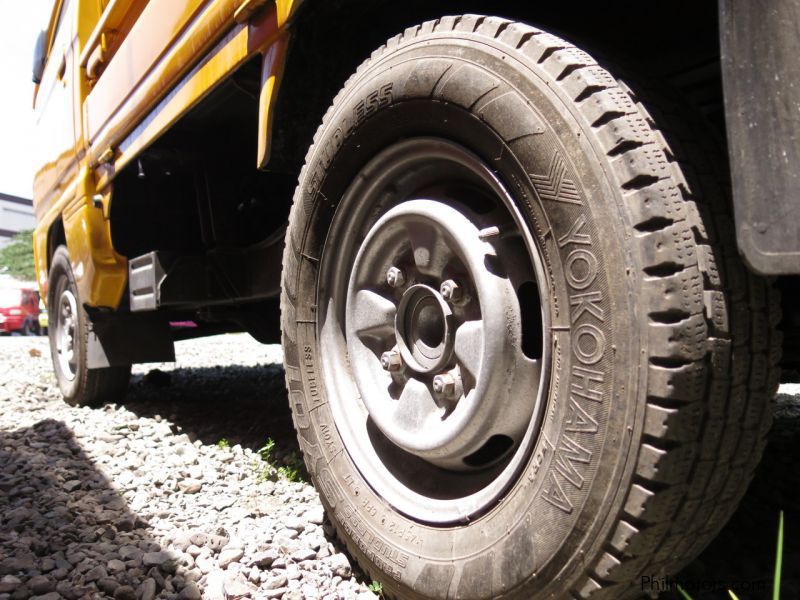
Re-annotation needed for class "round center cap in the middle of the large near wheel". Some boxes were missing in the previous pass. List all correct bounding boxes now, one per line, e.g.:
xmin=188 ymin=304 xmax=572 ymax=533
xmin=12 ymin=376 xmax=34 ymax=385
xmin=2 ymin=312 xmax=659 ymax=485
xmin=394 ymin=284 xmax=453 ymax=373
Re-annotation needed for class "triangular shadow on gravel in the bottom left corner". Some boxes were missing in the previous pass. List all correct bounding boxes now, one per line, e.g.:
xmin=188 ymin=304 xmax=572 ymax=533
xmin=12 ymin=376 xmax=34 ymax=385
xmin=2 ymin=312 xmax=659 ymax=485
xmin=0 ymin=419 xmax=174 ymax=600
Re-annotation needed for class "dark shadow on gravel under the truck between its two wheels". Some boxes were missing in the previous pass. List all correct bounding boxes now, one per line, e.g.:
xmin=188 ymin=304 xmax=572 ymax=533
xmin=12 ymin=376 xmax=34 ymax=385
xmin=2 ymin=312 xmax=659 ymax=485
xmin=124 ymin=364 xmax=299 ymax=459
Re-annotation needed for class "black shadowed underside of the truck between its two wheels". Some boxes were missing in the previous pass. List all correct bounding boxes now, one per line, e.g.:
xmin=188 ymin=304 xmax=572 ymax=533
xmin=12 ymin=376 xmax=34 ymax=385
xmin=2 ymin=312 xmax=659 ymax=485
xmin=109 ymin=57 xmax=286 ymax=342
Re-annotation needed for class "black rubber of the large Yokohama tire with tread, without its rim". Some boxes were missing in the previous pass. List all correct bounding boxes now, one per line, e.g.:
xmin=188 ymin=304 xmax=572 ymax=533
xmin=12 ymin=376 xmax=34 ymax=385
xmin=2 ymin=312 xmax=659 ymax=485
xmin=281 ymin=16 xmax=781 ymax=599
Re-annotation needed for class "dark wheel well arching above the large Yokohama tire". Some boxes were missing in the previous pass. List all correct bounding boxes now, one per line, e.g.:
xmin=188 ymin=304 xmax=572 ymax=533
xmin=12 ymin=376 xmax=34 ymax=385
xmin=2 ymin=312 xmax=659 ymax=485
xmin=269 ymin=0 xmax=723 ymax=173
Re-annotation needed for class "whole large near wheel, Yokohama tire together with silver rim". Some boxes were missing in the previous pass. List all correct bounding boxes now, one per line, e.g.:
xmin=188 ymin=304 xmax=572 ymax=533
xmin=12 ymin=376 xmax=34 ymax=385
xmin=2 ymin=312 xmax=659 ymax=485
xmin=281 ymin=16 xmax=780 ymax=599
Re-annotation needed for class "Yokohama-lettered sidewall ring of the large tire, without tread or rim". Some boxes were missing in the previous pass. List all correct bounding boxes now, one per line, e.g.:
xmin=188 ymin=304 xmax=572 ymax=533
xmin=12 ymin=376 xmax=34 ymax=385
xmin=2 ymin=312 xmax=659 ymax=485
xmin=285 ymin=35 xmax=643 ymax=597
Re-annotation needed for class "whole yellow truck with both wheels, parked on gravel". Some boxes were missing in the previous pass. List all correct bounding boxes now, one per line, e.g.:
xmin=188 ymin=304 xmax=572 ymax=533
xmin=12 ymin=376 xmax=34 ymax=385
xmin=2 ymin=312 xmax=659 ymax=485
xmin=33 ymin=0 xmax=800 ymax=599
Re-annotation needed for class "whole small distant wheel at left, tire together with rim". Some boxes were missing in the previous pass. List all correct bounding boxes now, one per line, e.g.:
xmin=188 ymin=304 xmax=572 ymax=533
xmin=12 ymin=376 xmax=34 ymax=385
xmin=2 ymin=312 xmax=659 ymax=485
xmin=47 ymin=246 xmax=131 ymax=406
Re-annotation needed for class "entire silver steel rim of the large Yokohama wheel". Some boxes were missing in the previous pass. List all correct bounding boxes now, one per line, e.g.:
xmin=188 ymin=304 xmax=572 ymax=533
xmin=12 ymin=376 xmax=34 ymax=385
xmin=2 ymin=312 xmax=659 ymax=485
xmin=319 ymin=138 xmax=549 ymax=523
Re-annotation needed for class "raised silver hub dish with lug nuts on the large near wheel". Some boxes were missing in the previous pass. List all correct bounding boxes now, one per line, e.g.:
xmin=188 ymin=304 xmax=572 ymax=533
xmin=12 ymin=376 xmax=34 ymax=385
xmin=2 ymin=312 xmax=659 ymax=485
xmin=346 ymin=200 xmax=539 ymax=470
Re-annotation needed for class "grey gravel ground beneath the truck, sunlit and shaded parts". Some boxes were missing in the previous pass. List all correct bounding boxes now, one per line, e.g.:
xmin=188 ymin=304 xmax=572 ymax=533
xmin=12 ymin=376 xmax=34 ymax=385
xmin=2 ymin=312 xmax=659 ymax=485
xmin=0 ymin=334 xmax=800 ymax=600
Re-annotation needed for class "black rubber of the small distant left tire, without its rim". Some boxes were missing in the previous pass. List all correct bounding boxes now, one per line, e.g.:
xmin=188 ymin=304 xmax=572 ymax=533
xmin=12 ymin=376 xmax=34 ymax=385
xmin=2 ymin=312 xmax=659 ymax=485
xmin=47 ymin=246 xmax=131 ymax=406
